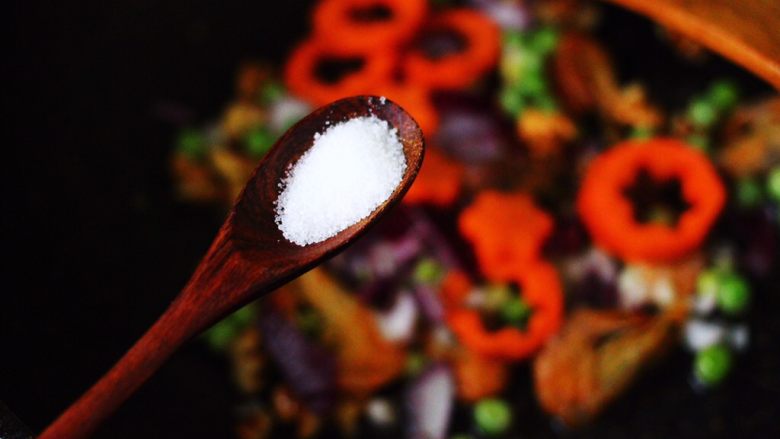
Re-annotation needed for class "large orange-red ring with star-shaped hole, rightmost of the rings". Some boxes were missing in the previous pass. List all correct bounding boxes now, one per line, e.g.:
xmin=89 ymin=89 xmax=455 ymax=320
xmin=577 ymin=138 xmax=726 ymax=262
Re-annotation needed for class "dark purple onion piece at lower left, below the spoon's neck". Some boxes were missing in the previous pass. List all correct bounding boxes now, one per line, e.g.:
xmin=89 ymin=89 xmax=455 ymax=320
xmin=260 ymin=311 xmax=337 ymax=414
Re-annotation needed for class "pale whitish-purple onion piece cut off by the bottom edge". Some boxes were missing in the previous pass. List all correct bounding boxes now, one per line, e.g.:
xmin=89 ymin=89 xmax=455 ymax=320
xmin=405 ymin=364 xmax=455 ymax=439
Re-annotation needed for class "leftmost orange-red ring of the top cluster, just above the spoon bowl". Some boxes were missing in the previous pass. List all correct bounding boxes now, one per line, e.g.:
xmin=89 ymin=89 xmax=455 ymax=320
xmin=284 ymin=39 xmax=396 ymax=105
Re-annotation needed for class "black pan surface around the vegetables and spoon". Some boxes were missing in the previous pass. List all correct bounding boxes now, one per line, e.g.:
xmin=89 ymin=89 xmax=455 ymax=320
xmin=6 ymin=1 xmax=780 ymax=438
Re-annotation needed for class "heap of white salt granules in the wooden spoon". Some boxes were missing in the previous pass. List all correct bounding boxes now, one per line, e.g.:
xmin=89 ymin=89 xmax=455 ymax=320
xmin=276 ymin=116 xmax=406 ymax=245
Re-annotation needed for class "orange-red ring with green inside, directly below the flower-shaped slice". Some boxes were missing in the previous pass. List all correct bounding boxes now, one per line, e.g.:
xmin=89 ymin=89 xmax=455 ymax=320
xmin=446 ymin=261 xmax=563 ymax=361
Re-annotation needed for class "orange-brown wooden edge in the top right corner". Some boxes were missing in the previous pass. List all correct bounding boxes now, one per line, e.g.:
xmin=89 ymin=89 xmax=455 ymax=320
xmin=605 ymin=0 xmax=780 ymax=89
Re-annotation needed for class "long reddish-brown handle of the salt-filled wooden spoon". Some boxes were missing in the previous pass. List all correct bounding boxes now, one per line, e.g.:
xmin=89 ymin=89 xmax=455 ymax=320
xmin=39 ymin=228 xmax=262 ymax=439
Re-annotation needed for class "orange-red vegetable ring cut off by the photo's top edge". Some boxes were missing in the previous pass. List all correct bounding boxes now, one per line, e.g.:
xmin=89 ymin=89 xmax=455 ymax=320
xmin=313 ymin=0 xmax=428 ymax=55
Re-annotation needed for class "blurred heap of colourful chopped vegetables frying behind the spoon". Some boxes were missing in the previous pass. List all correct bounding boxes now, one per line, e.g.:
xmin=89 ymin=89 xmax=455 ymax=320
xmin=172 ymin=0 xmax=780 ymax=438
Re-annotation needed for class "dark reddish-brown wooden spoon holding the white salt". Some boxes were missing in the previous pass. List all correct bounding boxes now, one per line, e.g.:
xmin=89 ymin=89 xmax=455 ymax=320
xmin=40 ymin=96 xmax=424 ymax=439
